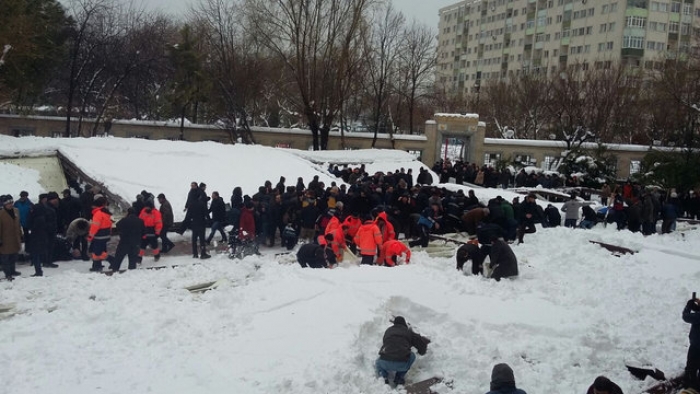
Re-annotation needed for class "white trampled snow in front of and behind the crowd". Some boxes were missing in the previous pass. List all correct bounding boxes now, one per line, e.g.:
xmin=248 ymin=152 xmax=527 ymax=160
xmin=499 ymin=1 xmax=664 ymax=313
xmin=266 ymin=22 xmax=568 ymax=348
xmin=0 ymin=135 xmax=700 ymax=394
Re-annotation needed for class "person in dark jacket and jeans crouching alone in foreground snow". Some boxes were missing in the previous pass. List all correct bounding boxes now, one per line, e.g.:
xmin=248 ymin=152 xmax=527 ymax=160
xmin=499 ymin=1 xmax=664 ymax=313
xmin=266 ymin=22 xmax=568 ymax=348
xmin=374 ymin=316 xmax=430 ymax=385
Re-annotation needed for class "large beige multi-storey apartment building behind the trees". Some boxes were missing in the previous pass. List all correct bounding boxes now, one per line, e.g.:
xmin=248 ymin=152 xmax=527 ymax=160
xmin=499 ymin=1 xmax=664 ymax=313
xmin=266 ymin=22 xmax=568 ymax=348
xmin=436 ymin=0 xmax=700 ymax=93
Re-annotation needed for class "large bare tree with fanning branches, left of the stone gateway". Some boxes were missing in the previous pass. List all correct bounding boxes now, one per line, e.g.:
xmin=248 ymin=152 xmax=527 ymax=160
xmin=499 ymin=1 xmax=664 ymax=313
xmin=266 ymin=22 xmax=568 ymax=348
xmin=245 ymin=0 xmax=372 ymax=149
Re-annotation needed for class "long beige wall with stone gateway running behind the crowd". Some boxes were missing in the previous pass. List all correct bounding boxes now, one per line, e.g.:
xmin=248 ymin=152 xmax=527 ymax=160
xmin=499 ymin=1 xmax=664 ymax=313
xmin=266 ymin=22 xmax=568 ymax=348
xmin=0 ymin=114 xmax=649 ymax=179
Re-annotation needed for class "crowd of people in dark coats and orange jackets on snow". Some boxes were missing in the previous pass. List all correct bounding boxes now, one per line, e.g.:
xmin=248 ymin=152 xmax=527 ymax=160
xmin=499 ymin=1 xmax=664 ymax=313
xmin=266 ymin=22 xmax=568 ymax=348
xmin=0 ymin=166 xmax=700 ymax=394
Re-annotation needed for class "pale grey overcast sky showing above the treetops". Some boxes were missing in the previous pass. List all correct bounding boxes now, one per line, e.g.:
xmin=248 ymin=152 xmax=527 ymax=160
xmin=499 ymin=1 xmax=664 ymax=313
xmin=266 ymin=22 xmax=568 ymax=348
xmin=112 ymin=0 xmax=459 ymax=31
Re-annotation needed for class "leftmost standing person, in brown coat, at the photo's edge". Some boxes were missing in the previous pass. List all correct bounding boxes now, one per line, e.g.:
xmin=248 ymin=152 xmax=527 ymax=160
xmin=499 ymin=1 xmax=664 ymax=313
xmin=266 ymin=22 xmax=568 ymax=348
xmin=0 ymin=195 xmax=22 ymax=280
